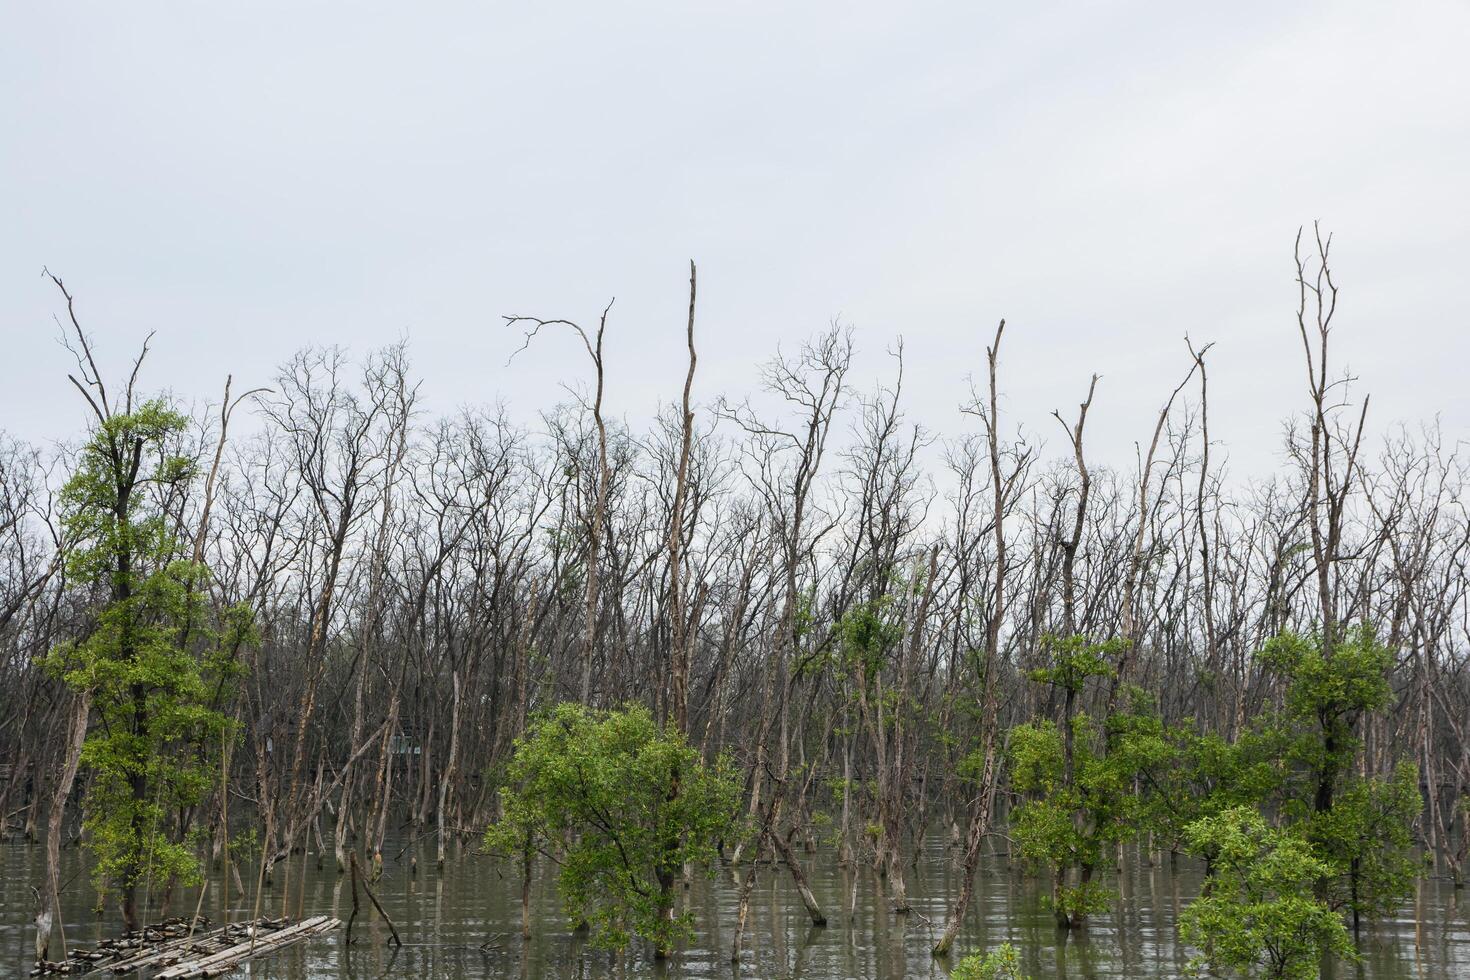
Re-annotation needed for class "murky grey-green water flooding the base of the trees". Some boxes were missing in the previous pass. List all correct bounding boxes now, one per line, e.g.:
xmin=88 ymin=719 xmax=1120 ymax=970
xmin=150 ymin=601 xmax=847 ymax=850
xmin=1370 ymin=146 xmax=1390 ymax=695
xmin=0 ymin=843 xmax=1470 ymax=980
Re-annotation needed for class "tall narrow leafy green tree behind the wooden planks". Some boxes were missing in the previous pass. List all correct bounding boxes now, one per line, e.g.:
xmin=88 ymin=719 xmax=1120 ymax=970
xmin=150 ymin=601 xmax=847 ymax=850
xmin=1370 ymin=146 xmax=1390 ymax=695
xmin=44 ymin=398 xmax=251 ymax=929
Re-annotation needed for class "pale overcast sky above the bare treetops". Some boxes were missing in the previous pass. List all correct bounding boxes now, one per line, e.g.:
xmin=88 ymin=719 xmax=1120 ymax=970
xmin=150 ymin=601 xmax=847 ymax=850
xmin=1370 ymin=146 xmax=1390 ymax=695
xmin=0 ymin=0 xmax=1470 ymax=475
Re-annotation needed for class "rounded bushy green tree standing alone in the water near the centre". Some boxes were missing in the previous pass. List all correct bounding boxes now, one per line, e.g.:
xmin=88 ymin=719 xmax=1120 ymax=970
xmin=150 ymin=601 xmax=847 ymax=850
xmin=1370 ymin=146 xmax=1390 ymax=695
xmin=485 ymin=704 xmax=739 ymax=956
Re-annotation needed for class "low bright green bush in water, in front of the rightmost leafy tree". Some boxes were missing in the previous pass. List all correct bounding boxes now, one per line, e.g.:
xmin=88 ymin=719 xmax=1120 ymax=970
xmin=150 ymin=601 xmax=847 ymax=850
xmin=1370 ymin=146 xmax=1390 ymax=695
xmin=1179 ymin=807 xmax=1355 ymax=980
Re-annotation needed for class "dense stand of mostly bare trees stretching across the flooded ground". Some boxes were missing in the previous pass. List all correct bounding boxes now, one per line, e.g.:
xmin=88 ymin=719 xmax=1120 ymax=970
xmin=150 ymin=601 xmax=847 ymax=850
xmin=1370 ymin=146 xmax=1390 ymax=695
xmin=0 ymin=231 xmax=1470 ymax=976
